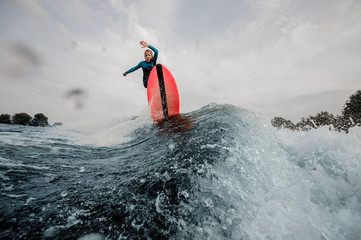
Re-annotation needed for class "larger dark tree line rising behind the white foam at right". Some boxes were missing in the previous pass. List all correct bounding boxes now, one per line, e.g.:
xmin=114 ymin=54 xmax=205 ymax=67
xmin=271 ymin=90 xmax=361 ymax=133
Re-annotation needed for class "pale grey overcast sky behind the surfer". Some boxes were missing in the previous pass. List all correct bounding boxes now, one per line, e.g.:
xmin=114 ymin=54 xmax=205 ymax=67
xmin=0 ymin=0 xmax=361 ymax=123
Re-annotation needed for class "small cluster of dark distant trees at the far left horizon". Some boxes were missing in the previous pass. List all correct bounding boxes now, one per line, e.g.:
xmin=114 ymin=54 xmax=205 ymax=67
xmin=0 ymin=113 xmax=50 ymax=127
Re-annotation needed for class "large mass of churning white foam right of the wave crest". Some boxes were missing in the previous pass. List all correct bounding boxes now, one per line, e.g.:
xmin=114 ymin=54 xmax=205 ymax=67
xmin=194 ymin=114 xmax=361 ymax=239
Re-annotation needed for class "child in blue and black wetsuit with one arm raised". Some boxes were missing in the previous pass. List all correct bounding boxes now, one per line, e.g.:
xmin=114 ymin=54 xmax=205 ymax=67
xmin=123 ymin=41 xmax=158 ymax=88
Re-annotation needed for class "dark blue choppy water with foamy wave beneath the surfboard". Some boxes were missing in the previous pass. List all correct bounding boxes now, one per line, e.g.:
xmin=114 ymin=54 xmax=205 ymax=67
xmin=0 ymin=104 xmax=361 ymax=240
